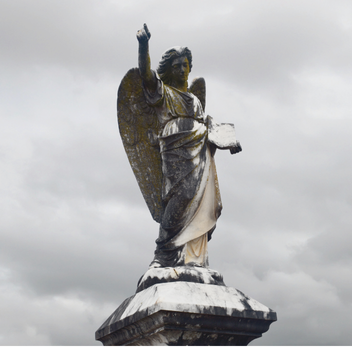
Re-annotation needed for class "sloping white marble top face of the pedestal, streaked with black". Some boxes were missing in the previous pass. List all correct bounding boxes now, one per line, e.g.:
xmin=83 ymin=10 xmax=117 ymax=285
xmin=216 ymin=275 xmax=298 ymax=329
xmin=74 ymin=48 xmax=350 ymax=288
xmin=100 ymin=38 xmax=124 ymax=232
xmin=120 ymin=282 xmax=271 ymax=319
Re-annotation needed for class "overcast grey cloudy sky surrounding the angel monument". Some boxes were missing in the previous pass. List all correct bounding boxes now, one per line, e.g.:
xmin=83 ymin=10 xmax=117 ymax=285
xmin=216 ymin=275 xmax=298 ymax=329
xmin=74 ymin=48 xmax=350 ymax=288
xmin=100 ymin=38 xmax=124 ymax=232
xmin=0 ymin=0 xmax=352 ymax=345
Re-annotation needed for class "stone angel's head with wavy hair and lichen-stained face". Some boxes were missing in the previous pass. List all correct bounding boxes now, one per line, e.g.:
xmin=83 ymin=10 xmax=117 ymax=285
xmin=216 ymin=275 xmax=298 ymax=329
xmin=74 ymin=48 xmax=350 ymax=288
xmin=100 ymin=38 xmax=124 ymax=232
xmin=156 ymin=46 xmax=192 ymax=85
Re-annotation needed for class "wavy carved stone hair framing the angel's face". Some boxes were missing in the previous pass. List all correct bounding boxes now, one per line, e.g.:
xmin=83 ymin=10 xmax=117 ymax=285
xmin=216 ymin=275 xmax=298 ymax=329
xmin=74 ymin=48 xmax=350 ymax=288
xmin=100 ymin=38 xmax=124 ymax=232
xmin=156 ymin=46 xmax=192 ymax=85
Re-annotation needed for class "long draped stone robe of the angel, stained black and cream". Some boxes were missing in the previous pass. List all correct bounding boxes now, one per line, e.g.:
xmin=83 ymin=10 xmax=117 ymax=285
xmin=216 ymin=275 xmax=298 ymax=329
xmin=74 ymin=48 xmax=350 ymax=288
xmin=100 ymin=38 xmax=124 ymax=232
xmin=144 ymin=78 xmax=222 ymax=267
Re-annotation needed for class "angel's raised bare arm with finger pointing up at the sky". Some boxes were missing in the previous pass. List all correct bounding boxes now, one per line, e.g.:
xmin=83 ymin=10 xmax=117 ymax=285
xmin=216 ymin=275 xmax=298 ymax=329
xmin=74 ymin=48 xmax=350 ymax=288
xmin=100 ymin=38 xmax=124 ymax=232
xmin=137 ymin=24 xmax=157 ymax=90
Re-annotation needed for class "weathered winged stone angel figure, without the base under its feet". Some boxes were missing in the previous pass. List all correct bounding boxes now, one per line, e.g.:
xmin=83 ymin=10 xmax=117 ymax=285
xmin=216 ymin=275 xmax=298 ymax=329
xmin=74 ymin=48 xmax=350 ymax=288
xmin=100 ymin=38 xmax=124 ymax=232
xmin=117 ymin=24 xmax=242 ymax=280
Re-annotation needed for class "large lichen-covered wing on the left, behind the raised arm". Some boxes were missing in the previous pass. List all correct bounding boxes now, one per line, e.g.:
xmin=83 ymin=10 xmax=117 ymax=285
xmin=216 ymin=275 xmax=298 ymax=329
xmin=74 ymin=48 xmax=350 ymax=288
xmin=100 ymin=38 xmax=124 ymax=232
xmin=117 ymin=68 xmax=163 ymax=223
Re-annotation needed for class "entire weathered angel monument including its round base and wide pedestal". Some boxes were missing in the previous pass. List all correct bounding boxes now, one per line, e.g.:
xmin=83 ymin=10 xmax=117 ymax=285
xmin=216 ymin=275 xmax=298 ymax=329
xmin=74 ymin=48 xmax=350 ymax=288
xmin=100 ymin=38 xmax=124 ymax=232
xmin=96 ymin=24 xmax=276 ymax=345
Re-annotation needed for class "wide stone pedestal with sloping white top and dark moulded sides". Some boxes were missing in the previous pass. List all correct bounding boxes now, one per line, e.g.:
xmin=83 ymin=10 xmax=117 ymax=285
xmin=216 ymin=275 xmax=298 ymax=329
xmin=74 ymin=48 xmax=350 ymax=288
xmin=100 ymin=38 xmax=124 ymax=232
xmin=95 ymin=282 xmax=276 ymax=346
